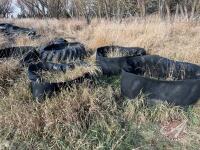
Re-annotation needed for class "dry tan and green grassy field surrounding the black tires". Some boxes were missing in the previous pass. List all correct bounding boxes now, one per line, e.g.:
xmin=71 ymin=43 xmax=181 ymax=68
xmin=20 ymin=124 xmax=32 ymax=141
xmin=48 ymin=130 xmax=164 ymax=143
xmin=0 ymin=16 xmax=200 ymax=150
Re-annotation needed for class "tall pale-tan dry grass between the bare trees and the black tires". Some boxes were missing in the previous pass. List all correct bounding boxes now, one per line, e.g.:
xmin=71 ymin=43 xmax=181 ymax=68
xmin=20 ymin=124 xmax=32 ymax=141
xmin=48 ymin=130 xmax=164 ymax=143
xmin=2 ymin=17 xmax=200 ymax=64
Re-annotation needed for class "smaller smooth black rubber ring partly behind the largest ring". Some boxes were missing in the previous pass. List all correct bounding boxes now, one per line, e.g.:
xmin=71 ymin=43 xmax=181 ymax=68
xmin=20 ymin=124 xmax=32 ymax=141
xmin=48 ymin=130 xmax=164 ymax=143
xmin=96 ymin=46 xmax=146 ymax=75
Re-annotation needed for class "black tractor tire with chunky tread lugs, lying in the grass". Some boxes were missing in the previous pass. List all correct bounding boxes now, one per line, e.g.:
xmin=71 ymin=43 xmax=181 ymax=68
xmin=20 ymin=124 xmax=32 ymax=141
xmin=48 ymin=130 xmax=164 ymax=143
xmin=39 ymin=38 xmax=86 ymax=62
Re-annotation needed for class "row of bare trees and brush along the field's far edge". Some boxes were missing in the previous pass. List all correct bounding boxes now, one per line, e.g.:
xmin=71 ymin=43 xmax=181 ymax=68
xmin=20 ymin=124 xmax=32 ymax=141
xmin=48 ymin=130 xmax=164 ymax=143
xmin=0 ymin=0 xmax=200 ymax=22
